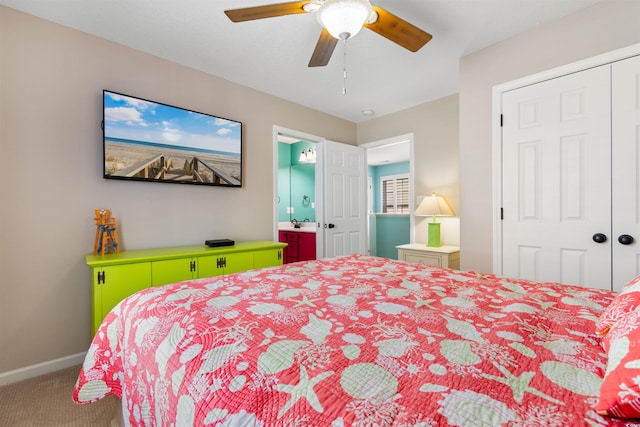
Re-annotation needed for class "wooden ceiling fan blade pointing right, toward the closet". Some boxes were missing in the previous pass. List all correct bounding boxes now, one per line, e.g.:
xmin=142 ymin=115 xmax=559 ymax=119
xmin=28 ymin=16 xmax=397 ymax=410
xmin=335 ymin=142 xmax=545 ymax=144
xmin=364 ymin=6 xmax=432 ymax=52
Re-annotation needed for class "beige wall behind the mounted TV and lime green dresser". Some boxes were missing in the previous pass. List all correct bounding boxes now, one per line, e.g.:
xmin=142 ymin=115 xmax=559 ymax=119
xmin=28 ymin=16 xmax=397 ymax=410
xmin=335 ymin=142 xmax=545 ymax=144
xmin=0 ymin=6 xmax=356 ymax=374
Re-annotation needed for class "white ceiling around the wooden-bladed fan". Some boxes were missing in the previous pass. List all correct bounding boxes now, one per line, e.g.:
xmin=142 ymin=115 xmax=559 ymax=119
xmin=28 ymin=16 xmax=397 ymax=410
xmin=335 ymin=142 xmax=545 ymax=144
xmin=0 ymin=0 xmax=604 ymax=123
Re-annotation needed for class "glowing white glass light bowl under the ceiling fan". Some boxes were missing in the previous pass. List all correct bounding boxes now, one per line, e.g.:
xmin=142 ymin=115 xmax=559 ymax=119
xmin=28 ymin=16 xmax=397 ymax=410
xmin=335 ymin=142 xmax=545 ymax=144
xmin=316 ymin=0 xmax=371 ymax=40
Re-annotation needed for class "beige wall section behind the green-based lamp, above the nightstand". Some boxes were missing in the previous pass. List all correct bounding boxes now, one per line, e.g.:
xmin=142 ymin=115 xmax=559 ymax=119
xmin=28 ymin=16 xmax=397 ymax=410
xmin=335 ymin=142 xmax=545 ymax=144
xmin=358 ymin=94 xmax=460 ymax=246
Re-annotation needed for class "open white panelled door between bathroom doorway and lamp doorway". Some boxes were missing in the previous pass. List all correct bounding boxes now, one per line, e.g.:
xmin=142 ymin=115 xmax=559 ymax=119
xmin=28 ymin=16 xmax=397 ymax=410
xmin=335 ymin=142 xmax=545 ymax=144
xmin=322 ymin=141 xmax=367 ymax=257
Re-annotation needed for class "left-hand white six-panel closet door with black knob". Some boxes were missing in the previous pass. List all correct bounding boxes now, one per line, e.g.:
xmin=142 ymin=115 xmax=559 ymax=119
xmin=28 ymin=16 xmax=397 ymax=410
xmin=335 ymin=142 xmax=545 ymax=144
xmin=502 ymin=65 xmax=612 ymax=289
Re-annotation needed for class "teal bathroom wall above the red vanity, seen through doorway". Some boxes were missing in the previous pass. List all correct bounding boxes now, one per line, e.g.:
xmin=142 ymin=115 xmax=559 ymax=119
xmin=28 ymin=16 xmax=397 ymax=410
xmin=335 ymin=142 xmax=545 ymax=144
xmin=278 ymin=141 xmax=316 ymax=222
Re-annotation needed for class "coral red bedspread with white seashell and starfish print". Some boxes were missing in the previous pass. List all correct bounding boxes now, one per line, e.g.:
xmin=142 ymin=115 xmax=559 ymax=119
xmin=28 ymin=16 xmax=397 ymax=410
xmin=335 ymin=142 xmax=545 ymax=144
xmin=73 ymin=256 xmax=625 ymax=427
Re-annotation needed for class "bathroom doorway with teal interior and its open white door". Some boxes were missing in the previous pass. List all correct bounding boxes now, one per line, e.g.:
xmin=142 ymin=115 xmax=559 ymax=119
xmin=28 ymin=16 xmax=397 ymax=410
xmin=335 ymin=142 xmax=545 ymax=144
xmin=273 ymin=126 xmax=367 ymax=259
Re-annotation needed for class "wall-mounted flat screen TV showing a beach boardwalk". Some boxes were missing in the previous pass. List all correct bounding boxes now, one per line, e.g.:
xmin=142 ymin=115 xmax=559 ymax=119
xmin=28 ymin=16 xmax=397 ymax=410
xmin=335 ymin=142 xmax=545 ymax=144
xmin=103 ymin=90 xmax=242 ymax=187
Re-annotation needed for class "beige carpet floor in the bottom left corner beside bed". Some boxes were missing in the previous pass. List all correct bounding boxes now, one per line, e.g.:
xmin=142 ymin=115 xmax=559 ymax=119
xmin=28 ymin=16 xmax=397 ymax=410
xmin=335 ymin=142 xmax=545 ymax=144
xmin=0 ymin=366 xmax=118 ymax=427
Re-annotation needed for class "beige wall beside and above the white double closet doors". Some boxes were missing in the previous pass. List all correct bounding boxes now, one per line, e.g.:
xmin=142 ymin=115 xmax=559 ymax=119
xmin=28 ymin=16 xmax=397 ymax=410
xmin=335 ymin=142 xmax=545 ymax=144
xmin=460 ymin=0 xmax=640 ymax=272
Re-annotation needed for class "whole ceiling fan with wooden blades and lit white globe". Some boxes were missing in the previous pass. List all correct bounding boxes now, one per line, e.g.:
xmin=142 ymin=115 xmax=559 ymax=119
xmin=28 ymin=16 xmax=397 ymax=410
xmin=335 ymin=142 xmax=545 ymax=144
xmin=224 ymin=0 xmax=432 ymax=67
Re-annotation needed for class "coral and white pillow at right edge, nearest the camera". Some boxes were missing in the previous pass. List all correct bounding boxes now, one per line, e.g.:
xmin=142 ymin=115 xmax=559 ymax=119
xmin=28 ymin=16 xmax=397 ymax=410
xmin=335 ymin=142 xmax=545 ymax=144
xmin=595 ymin=308 xmax=640 ymax=418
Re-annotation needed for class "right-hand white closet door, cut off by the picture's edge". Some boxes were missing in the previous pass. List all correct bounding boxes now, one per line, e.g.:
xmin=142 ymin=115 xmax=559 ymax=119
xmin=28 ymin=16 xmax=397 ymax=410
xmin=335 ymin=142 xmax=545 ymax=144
xmin=611 ymin=57 xmax=640 ymax=291
